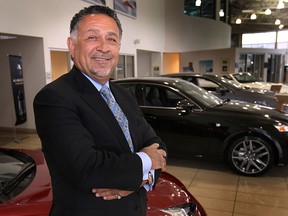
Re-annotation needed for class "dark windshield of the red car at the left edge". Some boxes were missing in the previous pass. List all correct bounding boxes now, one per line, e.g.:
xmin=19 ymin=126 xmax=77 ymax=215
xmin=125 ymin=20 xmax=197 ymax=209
xmin=0 ymin=150 xmax=36 ymax=204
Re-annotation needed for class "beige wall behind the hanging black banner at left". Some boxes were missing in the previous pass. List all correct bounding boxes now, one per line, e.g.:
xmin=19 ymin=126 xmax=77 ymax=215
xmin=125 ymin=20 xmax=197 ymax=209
xmin=0 ymin=37 xmax=46 ymax=129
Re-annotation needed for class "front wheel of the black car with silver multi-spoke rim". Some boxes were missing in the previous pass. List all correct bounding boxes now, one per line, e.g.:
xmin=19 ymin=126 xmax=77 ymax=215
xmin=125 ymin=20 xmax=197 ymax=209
xmin=226 ymin=136 xmax=274 ymax=176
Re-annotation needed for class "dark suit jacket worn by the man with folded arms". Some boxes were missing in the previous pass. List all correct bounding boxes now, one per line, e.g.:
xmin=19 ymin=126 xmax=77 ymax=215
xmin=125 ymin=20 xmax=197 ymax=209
xmin=34 ymin=67 xmax=165 ymax=216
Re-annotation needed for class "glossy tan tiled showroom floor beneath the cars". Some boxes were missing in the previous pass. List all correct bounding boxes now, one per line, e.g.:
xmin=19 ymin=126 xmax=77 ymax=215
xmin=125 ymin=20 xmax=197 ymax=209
xmin=0 ymin=131 xmax=288 ymax=216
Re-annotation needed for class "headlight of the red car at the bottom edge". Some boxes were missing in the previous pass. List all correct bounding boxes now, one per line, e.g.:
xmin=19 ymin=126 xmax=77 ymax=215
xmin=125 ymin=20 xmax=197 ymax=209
xmin=161 ymin=203 xmax=196 ymax=216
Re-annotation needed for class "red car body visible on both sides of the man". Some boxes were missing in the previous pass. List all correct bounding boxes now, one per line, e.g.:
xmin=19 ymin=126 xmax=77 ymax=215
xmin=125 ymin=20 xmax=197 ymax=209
xmin=0 ymin=148 xmax=206 ymax=216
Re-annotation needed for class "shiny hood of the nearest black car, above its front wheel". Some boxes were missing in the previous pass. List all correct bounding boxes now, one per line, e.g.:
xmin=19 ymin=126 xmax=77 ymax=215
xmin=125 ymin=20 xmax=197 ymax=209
xmin=213 ymin=100 xmax=288 ymax=122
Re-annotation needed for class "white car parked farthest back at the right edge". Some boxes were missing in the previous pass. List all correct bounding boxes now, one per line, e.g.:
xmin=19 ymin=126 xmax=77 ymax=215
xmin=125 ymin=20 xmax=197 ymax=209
xmin=223 ymin=72 xmax=288 ymax=93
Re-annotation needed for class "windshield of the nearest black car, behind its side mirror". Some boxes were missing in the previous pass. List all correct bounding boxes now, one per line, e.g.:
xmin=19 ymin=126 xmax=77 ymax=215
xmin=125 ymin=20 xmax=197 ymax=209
xmin=173 ymin=80 xmax=223 ymax=107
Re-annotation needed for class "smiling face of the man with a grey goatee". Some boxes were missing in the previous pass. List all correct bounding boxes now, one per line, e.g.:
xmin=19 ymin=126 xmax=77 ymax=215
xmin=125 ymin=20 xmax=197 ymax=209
xmin=67 ymin=14 xmax=120 ymax=84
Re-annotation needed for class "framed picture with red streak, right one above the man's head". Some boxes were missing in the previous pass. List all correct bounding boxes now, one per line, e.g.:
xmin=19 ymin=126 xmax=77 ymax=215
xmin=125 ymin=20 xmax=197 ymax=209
xmin=114 ymin=0 xmax=137 ymax=18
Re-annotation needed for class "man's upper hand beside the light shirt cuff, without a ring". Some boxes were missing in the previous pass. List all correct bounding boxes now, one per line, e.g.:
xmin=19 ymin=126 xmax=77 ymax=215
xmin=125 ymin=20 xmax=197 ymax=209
xmin=140 ymin=143 xmax=167 ymax=171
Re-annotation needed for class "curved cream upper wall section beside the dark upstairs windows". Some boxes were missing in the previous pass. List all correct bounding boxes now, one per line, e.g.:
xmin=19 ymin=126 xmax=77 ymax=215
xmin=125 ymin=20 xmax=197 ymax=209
xmin=165 ymin=0 xmax=231 ymax=52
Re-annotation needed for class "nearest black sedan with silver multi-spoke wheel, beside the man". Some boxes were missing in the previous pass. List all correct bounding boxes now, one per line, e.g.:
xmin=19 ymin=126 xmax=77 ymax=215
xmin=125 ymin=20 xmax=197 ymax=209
xmin=114 ymin=77 xmax=288 ymax=176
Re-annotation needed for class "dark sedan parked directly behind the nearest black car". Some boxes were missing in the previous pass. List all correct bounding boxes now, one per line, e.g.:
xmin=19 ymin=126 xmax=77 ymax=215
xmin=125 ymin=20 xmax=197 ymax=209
xmin=161 ymin=72 xmax=279 ymax=109
